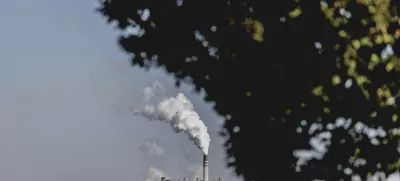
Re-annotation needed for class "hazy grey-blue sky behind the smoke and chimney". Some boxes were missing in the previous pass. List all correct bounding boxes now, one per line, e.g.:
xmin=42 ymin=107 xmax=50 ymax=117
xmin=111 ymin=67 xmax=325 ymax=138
xmin=0 ymin=0 xmax=241 ymax=181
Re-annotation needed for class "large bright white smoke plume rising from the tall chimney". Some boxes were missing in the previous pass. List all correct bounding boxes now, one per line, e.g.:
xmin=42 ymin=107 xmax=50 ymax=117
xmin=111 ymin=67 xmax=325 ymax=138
xmin=133 ymin=81 xmax=210 ymax=155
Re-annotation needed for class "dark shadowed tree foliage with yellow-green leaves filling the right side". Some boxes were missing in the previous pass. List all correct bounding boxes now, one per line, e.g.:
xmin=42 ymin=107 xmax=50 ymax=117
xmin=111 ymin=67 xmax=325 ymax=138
xmin=98 ymin=0 xmax=400 ymax=181
